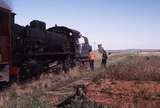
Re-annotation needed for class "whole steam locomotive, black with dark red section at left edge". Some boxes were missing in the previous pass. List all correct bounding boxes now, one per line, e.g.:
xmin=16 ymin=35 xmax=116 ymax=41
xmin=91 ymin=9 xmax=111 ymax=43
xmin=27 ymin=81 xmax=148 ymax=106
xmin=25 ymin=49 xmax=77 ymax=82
xmin=0 ymin=7 xmax=91 ymax=82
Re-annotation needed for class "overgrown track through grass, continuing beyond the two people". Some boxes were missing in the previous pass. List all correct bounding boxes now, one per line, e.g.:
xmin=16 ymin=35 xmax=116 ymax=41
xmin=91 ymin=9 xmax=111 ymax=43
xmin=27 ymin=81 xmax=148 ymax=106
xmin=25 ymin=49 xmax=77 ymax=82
xmin=48 ymin=54 xmax=134 ymax=107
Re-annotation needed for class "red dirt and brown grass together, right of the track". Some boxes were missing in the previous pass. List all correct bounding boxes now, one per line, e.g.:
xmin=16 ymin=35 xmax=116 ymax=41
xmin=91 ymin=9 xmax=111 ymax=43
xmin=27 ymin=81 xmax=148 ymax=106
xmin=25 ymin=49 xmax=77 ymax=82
xmin=86 ymin=52 xmax=160 ymax=108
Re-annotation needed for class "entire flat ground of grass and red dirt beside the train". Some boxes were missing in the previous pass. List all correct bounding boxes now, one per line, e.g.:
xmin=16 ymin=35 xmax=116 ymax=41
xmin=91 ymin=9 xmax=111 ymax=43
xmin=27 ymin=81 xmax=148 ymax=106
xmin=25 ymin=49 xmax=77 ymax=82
xmin=0 ymin=52 xmax=160 ymax=108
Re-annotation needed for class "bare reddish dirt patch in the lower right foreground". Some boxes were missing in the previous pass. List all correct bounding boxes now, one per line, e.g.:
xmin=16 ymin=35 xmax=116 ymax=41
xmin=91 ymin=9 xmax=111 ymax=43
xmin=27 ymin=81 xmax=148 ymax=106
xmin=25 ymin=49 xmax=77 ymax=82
xmin=86 ymin=79 xmax=160 ymax=108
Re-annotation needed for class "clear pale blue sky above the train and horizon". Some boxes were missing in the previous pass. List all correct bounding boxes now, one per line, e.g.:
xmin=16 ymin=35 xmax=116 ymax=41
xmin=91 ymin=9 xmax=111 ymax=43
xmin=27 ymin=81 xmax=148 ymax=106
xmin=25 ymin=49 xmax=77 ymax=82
xmin=9 ymin=0 xmax=160 ymax=50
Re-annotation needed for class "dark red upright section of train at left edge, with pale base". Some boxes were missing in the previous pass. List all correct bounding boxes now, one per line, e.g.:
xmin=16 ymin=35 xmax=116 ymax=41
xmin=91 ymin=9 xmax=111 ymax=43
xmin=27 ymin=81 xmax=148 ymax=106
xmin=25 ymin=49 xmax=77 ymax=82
xmin=0 ymin=7 xmax=11 ymax=82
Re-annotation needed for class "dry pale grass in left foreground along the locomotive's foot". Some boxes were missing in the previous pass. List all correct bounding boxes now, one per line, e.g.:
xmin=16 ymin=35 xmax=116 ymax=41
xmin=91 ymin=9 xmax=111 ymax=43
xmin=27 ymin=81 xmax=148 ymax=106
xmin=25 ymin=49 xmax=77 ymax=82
xmin=0 ymin=67 xmax=90 ymax=108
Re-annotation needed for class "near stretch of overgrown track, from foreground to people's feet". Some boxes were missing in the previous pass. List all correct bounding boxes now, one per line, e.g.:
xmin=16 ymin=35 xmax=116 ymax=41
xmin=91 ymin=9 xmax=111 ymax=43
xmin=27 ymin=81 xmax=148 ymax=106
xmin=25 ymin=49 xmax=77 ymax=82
xmin=46 ymin=68 xmax=105 ymax=107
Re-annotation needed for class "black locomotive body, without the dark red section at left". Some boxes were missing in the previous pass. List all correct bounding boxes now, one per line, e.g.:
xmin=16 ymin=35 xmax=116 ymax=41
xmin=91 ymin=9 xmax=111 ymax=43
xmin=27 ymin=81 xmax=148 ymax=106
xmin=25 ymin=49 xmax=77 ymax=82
xmin=12 ymin=20 xmax=83 ymax=79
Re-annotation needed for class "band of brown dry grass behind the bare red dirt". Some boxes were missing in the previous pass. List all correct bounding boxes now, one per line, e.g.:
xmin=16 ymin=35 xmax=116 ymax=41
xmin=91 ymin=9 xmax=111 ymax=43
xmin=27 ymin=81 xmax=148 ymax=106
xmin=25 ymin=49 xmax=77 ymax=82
xmin=107 ymin=56 xmax=160 ymax=81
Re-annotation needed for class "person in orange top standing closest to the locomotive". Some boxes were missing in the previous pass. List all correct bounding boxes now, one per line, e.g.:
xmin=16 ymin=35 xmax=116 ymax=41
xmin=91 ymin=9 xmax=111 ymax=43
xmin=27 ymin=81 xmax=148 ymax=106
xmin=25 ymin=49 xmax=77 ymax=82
xmin=88 ymin=49 xmax=96 ymax=71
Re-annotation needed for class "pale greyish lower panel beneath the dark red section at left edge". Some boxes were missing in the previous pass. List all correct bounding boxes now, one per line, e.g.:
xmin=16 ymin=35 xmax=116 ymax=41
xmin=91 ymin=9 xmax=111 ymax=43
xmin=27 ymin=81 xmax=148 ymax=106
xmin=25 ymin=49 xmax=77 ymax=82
xmin=0 ymin=64 xmax=9 ymax=82
